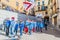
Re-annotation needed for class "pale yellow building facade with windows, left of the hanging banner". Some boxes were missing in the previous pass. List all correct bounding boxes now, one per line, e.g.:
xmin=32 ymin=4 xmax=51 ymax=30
xmin=1 ymin=0 xmax=23 ymax=12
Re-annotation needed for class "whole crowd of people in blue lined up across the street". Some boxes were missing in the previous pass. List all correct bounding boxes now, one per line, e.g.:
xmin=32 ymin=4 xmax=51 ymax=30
xmin=3 ymin=17 xmax=48 ymax=37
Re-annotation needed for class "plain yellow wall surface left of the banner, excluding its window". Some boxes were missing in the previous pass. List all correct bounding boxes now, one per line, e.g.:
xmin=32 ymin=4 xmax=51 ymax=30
xmin=1 ymin=0 xmax=23 ymax=11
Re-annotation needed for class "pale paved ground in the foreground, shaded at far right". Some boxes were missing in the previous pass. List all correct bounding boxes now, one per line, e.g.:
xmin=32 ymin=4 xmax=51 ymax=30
xmin=0 ymin=28 xmax=60 ymax=40
